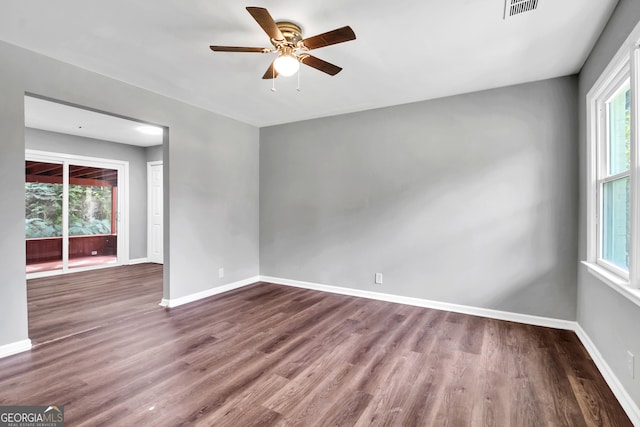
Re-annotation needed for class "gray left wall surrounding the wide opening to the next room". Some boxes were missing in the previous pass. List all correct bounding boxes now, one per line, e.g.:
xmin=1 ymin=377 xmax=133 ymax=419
xmin=0 ymin=38 xmax=259 ymax=346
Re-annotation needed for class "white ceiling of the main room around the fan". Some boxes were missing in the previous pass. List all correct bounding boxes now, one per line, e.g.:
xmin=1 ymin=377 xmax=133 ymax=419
xmin=0 ymin=0 xmax=617 ymax=126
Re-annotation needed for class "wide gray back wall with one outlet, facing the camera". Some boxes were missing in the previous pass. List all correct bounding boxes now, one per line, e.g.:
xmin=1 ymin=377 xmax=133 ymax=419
xmin=260 ymin=76 xmax=578 ymax=320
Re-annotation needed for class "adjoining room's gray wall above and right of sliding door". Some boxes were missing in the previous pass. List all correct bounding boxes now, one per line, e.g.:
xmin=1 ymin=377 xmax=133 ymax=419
xmin=24 ymin=128 xmax=150 ymax=259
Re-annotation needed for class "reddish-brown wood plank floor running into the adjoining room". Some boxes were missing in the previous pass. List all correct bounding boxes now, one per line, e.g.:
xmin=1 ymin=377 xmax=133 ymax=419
xmin=0 ymin=266 xmax=631 ymax=427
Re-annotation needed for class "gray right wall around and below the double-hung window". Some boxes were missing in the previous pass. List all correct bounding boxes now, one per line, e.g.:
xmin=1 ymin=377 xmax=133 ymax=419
xmin=578 ymin=0 xmax=640 ymax=403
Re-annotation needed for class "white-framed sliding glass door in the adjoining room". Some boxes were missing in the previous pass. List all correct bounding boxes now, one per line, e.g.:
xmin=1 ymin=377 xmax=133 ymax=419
xmin=25 ymin=153 xmax=123 ymax=277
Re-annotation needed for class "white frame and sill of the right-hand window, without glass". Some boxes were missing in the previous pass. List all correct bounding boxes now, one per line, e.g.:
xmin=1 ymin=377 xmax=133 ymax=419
xmin=583 ymin=20 xmax=640 ymax=305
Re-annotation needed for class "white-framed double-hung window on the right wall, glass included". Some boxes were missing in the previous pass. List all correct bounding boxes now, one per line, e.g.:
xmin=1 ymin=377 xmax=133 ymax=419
xmin=585 ymin=20 xmax=640 ymax=294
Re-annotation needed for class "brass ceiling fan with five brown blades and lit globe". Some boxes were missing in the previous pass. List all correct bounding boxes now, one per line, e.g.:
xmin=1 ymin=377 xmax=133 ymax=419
xmin=209 ymin=7 xmax=356 ymax=79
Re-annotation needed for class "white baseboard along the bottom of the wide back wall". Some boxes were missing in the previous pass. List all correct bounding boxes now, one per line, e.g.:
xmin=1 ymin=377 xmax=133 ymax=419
xmin=260 ymin=276 xmax=576 ymax=330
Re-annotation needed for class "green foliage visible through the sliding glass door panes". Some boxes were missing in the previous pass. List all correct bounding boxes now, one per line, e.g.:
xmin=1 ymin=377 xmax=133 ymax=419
xmin=25 ymin=182 xmax=111 ymax=239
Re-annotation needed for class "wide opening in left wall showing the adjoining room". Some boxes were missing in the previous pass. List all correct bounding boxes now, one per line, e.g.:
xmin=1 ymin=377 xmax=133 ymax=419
xmin=24 ymin=94 xmax=168 ymax=343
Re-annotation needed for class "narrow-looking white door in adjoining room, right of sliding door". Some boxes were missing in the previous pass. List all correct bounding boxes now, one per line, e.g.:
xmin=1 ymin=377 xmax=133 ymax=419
xmin=147 ymin=162 xmax=163 ymax=264
